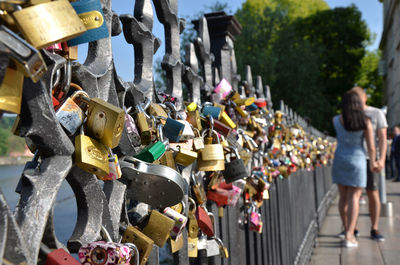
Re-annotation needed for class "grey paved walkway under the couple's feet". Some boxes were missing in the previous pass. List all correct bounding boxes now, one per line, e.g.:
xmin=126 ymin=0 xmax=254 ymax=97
xmin=310 ymin=180 xmax=400 ymax=265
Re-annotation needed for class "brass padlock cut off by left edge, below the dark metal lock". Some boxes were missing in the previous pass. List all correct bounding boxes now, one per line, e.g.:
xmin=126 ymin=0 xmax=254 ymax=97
xmin=0 ymin=67 xmax=24 ymax=114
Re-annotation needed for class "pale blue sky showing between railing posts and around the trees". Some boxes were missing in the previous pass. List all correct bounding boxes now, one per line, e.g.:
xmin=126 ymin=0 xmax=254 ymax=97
xmin=79 ymin=0 xmax=383 ymax=81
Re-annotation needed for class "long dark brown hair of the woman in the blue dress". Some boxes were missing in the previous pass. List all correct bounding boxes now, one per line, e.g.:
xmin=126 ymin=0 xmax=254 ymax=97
xmin=341 ymin=90 xmax=367 ymax=131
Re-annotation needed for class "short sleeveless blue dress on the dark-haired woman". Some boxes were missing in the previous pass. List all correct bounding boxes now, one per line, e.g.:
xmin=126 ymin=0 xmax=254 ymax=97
xmin=332 ymin=115 xmax=367 ymax=188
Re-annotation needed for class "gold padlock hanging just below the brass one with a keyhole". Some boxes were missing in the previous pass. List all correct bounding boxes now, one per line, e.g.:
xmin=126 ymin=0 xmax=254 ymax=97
xmin=75 ymin=122 xmax=110 ymax=177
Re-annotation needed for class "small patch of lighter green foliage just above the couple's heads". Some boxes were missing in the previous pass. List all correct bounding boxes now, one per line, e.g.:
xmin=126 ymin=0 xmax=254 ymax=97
xmin=355 ymin=50 xmax=383 ymax=108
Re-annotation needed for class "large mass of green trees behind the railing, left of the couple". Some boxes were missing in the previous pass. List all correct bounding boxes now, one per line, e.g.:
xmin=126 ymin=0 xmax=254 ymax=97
xmin=235 ymin=0 xmax=370 ymax=132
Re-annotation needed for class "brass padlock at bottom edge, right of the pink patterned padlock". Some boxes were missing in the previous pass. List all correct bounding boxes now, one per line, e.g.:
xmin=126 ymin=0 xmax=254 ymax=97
xmin=121 ymin=225 xmax=154 ymax=265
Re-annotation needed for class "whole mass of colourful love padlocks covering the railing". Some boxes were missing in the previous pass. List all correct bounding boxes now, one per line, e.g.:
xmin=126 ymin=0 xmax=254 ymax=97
xmin=0 ymin=0 xmax=334 ymax=265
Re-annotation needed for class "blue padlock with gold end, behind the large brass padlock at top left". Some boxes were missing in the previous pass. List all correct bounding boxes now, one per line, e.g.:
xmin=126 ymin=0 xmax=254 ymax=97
xmin=67 ymin=0 xmax=109 ymax=46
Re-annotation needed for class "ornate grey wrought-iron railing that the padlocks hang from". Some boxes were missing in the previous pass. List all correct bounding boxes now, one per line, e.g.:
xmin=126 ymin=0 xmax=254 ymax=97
xmin=0 ymin=0 xmax=335 ymax=265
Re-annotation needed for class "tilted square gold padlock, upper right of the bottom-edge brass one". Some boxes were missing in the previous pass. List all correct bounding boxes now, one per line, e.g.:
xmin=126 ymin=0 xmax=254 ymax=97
xmin=143 ymin=210 xmax=175 ymax=248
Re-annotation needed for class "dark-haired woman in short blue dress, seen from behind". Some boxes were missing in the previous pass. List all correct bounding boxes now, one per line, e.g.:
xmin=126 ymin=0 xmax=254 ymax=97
xmin=332 ymin=91 xmax=377 ymax=247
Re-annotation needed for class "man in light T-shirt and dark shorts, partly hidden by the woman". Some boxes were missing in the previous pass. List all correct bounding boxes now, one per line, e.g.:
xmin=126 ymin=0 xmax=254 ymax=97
xmin=351 ymin=87 xmax=388 ymax=241
